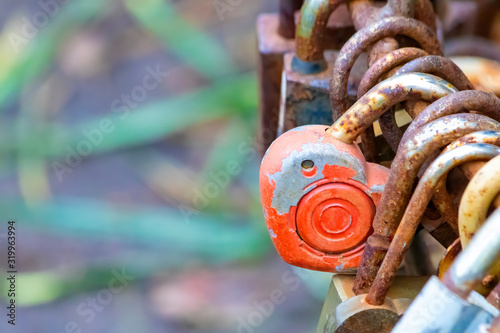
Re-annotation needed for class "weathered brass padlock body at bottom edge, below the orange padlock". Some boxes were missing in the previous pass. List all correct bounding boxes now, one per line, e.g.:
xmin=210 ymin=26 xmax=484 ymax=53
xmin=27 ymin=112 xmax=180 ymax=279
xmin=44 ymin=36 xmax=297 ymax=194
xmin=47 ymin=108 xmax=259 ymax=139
xmin=316 ymin=274 xmax=428 ymax=333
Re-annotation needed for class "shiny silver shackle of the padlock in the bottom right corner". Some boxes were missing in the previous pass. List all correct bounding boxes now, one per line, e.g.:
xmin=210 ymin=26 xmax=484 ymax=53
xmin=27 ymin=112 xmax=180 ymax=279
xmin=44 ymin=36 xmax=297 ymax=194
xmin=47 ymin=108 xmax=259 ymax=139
xmin=443 ymin=208 xmax=500 ymax=299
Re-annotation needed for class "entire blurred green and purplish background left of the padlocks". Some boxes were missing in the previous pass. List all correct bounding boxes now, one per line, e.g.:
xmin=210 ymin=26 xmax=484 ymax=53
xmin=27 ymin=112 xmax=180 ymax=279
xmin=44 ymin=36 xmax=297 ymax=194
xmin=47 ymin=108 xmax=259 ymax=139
xmin=0 ymin=0 xmax=336 ymax=333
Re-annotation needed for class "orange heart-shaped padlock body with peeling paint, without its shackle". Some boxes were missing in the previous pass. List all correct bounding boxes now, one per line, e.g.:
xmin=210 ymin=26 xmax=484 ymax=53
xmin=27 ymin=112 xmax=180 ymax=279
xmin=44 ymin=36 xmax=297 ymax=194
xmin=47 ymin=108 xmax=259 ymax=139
xmin=260 ymin=125 xmax=388 ymax=273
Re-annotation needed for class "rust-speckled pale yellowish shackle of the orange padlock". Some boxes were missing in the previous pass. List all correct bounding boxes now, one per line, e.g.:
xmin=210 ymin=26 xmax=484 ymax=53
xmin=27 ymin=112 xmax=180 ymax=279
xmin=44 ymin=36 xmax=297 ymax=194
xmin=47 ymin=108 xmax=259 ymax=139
xmin=328 ymin=73 xmax=457 ymax=144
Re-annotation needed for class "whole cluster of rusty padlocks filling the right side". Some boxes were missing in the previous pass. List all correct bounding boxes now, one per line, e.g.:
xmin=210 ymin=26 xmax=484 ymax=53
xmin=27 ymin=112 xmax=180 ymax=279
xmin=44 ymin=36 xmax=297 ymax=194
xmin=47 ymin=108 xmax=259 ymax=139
xmin=258 ymin=0 xmax=500 ymax=332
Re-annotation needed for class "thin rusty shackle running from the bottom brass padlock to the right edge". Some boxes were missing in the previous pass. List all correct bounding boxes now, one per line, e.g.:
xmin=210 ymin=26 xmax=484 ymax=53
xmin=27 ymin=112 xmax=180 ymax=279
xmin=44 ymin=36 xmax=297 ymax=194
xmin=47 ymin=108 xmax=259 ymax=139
xmin=366 ymin=143 xmax=500 ymax=305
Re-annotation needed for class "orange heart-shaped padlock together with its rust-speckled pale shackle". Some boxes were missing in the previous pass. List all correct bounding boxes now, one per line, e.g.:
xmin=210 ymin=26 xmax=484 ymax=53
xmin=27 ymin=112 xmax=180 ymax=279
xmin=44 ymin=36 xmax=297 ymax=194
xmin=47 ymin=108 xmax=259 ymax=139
xmin=260 ymin=74 xmax=455 ymax=272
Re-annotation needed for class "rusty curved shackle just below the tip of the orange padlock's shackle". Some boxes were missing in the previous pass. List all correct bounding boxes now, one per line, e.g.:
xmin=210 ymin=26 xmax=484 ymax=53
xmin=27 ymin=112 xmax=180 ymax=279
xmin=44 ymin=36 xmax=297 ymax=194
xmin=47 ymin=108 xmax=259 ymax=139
xmin=400 ymin=90 xmax=500 ymax=146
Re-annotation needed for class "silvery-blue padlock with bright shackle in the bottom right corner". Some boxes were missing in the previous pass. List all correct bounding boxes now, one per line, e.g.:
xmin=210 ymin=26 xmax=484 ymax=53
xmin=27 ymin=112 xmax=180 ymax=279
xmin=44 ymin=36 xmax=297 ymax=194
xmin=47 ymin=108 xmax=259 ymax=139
xmin=394 ymin=206 xmax=500 ymax=333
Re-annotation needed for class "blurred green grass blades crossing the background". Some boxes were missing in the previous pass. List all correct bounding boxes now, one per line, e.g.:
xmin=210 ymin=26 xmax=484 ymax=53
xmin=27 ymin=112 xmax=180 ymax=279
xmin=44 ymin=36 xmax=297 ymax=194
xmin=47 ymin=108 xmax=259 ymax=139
xmin=0 ymin=0 xmax=270 ymax=305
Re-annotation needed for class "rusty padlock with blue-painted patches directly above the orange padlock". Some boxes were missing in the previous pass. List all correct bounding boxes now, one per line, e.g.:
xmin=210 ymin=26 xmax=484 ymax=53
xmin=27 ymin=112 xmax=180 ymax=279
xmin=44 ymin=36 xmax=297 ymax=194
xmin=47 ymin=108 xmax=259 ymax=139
xmin=278 ymin=0 xmax=354 ymax=135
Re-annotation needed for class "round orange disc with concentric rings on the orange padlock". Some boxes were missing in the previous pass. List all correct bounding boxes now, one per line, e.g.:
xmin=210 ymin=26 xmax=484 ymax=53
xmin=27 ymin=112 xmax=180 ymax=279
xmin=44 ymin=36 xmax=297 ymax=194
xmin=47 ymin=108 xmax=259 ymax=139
xmin=296 ymin=183 xmax=375 ymax=254
